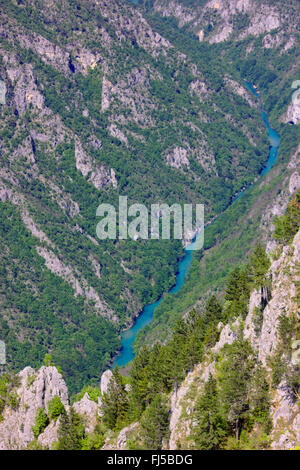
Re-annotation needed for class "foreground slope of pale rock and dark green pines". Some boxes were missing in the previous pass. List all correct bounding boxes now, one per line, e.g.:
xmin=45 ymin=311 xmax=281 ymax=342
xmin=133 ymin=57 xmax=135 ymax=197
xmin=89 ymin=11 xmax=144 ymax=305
xmin=0 ymin=204 xmax=300 ymax=450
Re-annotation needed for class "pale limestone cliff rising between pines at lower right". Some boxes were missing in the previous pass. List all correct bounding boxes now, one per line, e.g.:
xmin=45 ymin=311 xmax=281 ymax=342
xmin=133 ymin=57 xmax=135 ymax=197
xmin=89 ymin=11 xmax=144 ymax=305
xmin=169 ymin=232 xmax=300 ymax=449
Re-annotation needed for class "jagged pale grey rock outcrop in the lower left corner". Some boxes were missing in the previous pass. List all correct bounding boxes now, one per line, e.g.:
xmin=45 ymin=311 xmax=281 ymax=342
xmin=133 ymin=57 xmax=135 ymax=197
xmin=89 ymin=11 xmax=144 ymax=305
xmin=0 ymin=366 xmax=112 ymax=450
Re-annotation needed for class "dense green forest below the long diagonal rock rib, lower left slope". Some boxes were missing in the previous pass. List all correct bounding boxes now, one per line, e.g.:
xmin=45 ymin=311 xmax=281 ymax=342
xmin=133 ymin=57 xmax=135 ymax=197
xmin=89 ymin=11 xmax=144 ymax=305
xmin=0 ymin=203 xmax=120 ymax=393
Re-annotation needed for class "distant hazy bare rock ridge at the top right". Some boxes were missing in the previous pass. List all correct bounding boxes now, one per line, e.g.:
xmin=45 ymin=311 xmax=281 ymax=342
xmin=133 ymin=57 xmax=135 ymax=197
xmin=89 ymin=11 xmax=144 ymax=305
xmin=153 ymin=0 xmax=297 ymax=51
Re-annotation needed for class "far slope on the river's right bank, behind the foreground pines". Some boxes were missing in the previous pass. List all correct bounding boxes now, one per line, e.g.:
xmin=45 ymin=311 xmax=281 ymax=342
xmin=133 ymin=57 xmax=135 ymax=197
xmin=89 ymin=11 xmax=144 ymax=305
xmin=132 ymin=0 xmax=300 ymax=349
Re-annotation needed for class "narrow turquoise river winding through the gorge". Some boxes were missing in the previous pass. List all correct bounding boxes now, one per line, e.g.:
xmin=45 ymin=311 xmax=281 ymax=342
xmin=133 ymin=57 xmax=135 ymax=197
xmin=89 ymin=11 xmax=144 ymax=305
xmin=112 ymin=82 xmax=280 ymax=367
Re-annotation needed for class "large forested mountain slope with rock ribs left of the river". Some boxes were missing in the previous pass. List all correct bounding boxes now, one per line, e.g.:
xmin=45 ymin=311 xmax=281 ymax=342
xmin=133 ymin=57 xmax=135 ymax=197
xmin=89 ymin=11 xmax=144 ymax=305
xmin=0 ymin=0 xmax=278 ymax=390
